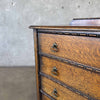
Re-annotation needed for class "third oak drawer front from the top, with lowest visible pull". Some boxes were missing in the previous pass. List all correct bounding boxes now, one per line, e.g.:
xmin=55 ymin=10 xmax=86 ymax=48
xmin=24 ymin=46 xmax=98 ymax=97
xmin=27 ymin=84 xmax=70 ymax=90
xmin=41 ymin=77 xmax=87 ymax=100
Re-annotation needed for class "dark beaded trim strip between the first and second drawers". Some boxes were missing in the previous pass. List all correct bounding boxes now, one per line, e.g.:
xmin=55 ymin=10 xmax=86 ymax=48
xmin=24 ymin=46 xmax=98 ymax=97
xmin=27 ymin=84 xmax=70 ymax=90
xmin=39 ymin=52 xmax=100 ymax=74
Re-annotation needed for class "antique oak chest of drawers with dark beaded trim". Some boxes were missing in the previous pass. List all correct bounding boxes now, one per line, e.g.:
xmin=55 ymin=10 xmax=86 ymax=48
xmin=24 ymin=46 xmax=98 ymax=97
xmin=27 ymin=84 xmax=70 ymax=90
xmin=30 ymin=26 xmax=100 ymax=100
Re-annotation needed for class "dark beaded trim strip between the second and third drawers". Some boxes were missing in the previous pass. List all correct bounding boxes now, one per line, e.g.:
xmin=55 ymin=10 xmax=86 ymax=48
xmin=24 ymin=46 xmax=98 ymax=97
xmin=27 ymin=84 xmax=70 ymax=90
xmin=39 ymin=72 xmax=98 ymax=100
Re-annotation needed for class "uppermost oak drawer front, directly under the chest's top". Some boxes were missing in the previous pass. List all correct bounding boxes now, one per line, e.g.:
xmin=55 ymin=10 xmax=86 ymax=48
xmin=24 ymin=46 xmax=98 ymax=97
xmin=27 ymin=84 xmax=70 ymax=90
xmin=39 ymin=33 xmax=100 ymax=68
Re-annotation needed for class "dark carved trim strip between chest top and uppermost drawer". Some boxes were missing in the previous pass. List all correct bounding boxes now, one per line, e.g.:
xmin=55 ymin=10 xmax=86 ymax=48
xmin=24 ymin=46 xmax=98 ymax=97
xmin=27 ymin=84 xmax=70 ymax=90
xmin=38 ymin=30 xmax=100 ymax=38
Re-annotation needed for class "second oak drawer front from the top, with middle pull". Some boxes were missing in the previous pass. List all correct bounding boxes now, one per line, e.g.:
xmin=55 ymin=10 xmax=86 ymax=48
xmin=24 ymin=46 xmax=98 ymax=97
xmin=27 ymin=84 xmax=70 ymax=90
xmin=41 ymin=57 xmax=100 ymax=99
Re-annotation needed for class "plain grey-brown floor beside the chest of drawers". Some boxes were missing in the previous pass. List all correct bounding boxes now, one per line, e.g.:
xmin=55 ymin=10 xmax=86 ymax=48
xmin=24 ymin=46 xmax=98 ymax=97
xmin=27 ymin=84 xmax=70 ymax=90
xmin=0 ymin=67 xmax=36 ymax=100
